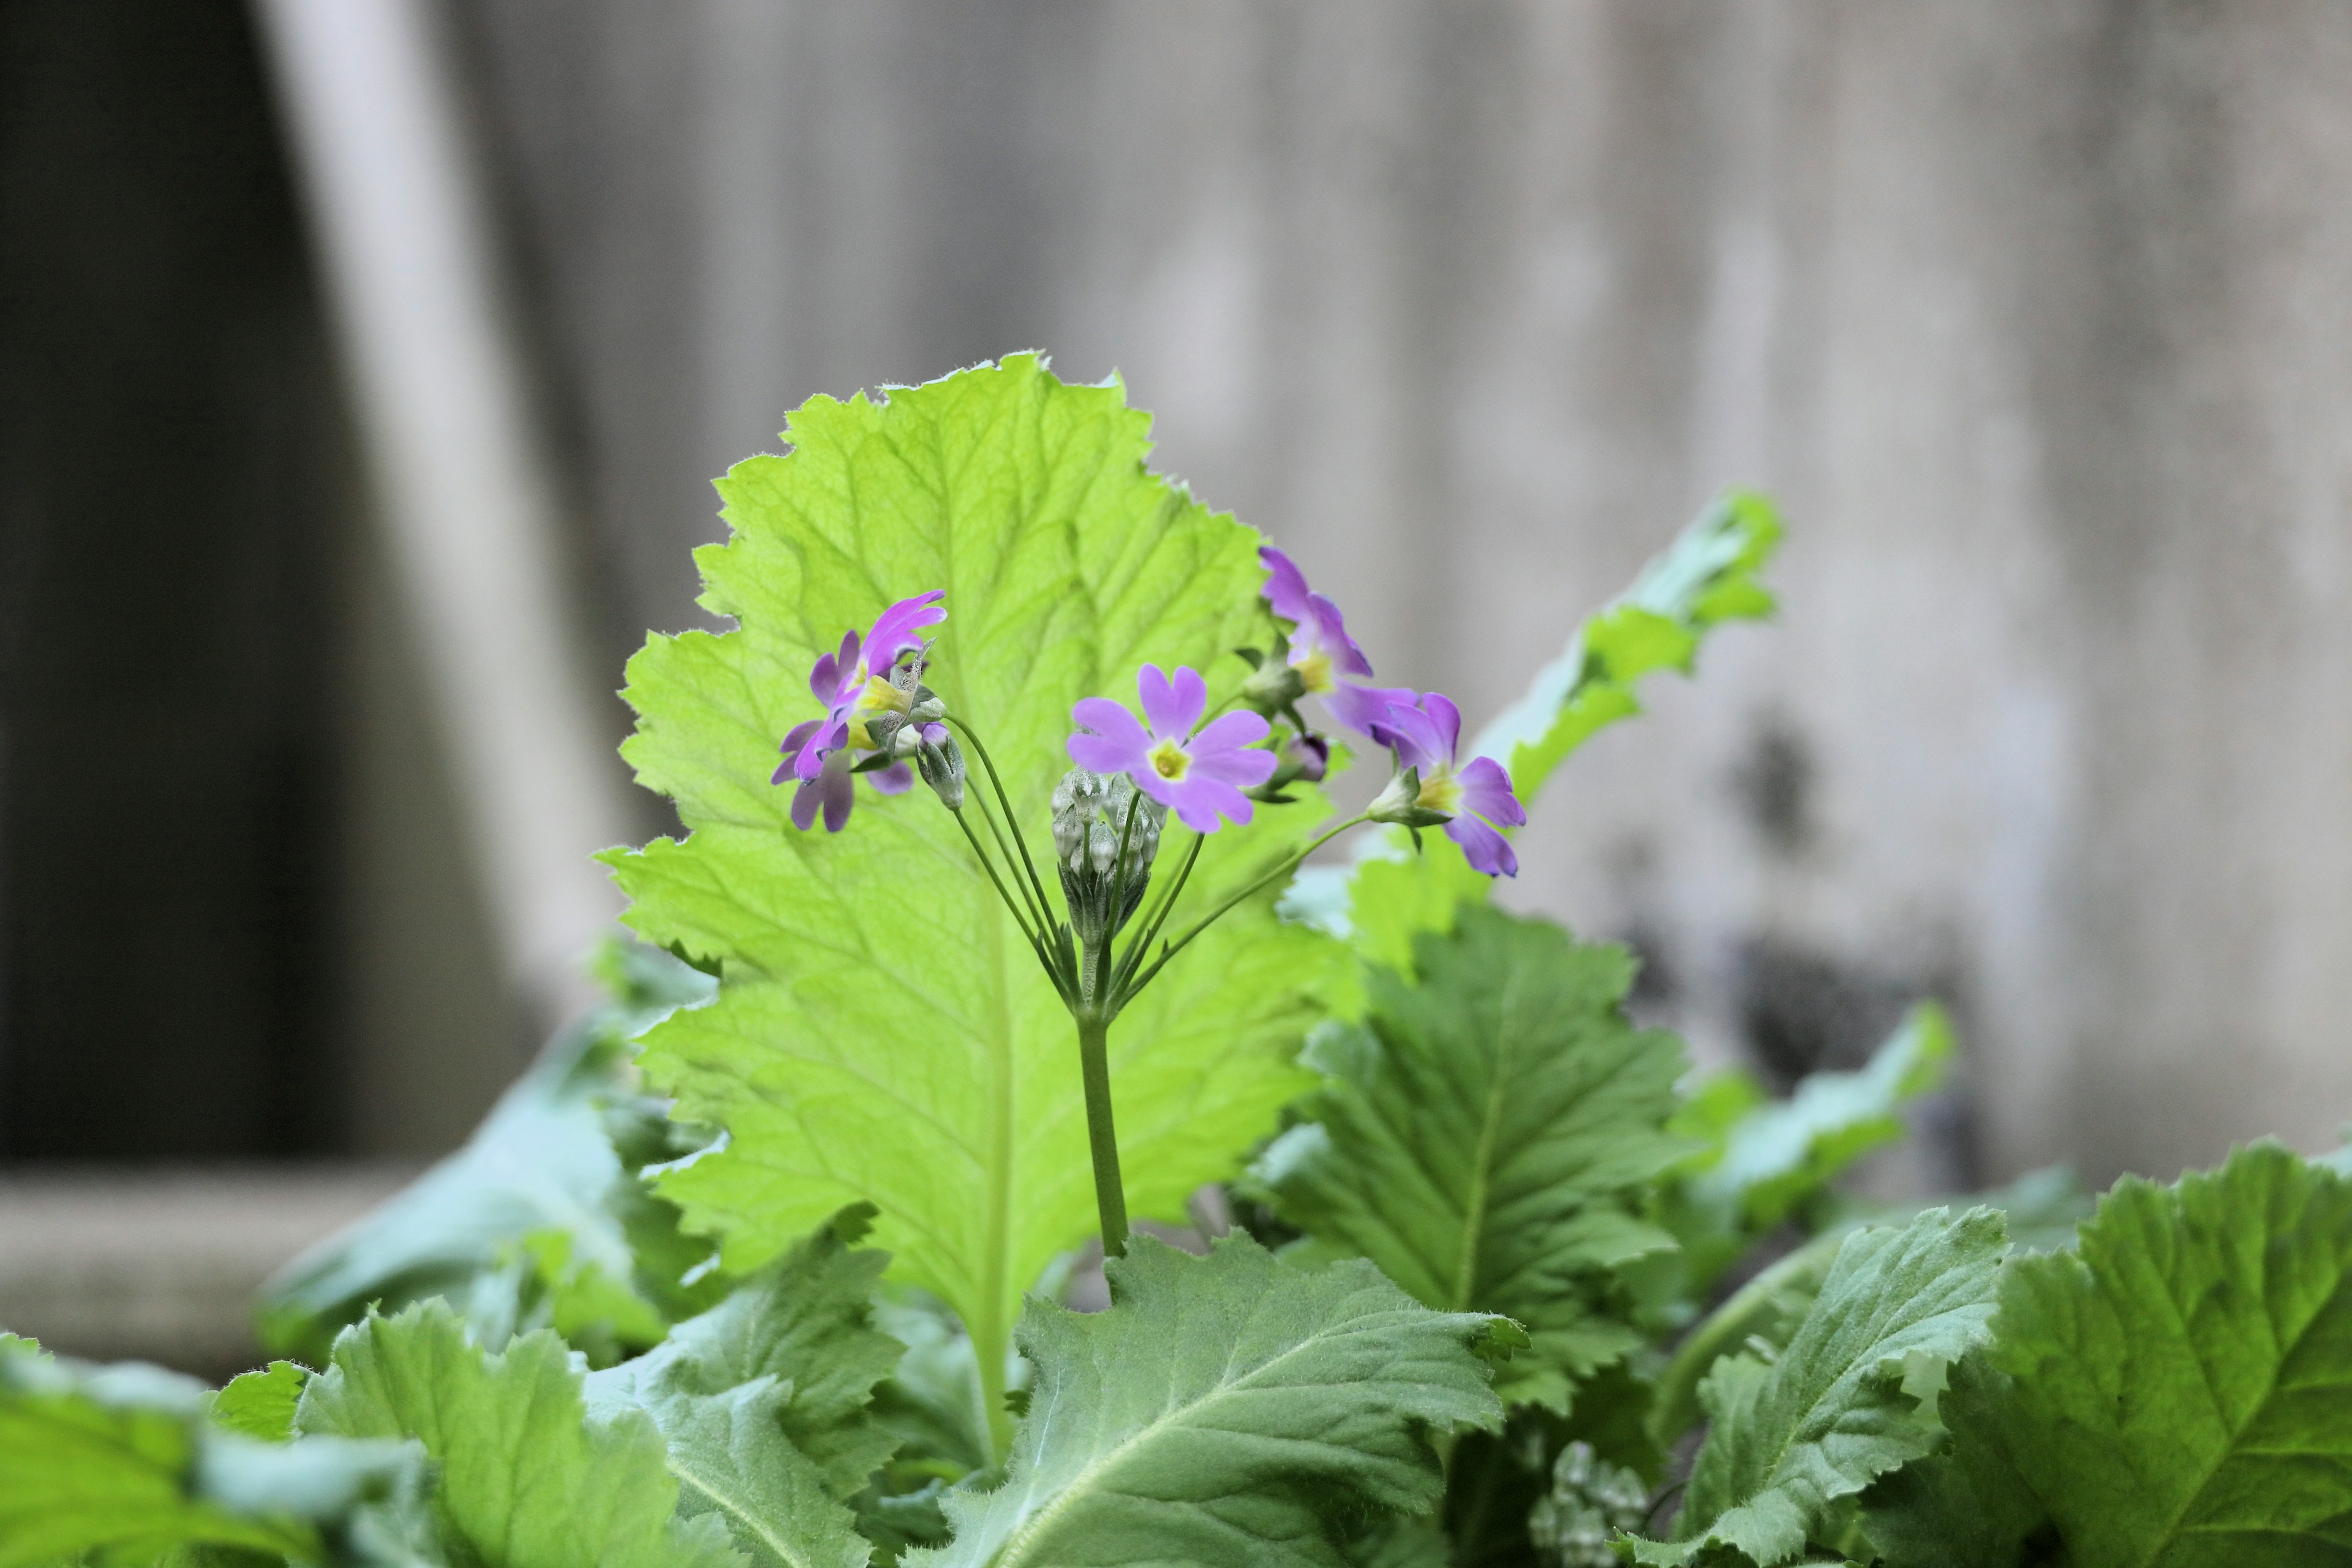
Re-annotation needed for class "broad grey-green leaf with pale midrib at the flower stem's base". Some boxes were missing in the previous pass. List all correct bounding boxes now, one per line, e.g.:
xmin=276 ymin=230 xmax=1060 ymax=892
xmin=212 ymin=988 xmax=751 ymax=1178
xmin=908 ymin=1234 xmax=1503 ymax=1568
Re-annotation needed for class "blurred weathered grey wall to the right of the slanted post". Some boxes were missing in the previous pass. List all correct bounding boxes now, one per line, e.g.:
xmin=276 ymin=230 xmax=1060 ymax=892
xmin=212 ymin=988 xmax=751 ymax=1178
xmin=463 ymin=0 xmax=2352 ymax=1178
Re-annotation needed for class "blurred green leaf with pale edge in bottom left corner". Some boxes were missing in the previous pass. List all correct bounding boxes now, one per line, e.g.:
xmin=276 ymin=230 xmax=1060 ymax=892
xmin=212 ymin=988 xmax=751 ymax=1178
xmin=0 ymin=1340 xmax=417 ymax=1568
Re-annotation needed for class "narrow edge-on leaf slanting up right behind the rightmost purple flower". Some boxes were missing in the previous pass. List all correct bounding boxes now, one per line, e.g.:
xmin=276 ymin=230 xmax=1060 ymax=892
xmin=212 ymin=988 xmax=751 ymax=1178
xmin=1282 ymin=489 xmax=1781 ymax=968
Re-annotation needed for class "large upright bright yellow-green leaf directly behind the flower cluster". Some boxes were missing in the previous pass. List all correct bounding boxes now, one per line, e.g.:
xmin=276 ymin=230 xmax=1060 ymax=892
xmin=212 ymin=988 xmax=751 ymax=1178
xmin=609 ymin=355 xmax=1341 ymax=1438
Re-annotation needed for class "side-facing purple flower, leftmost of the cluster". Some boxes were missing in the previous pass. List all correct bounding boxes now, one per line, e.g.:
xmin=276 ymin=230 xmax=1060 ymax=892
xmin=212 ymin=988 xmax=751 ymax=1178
xmin=769 ymin=588 xmax=948 ymax=832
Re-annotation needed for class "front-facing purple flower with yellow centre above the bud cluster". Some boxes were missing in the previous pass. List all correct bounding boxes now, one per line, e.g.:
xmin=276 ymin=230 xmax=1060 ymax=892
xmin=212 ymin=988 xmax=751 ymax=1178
xmin=1070 ymin=665 xmax=1275 ymax=832
